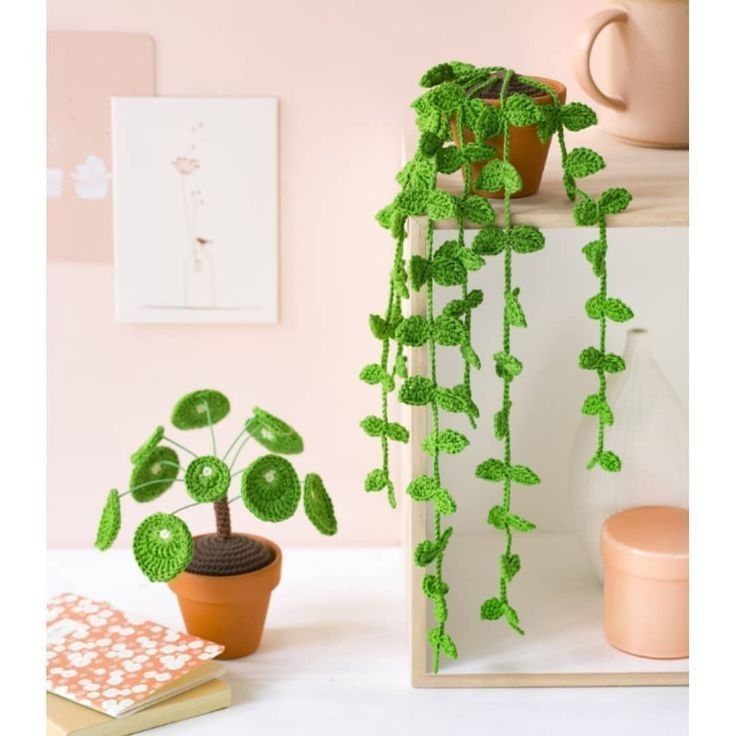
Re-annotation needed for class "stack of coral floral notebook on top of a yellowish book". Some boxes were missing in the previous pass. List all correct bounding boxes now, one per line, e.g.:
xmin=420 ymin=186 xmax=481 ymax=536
xmin=46 ymin=593 xmax=230 ymax=736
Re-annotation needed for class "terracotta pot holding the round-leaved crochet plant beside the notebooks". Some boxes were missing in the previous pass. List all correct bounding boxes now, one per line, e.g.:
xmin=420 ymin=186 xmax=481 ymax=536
xmin=169 ymin=534 xmax=281 ymax=659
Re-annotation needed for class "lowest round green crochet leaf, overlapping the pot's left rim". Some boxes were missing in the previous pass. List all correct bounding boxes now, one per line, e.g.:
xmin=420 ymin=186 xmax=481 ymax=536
xmin=133 ymin=513 xmax=194 ymax=582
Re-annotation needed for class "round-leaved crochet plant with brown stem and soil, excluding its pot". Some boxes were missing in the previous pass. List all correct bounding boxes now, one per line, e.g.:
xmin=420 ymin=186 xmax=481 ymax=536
xmin=95 ymin=389 xmax=337 ymax=581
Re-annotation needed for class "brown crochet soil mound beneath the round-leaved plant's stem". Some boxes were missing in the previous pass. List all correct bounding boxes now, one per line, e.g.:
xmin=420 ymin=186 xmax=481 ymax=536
xmin=187 ymin=534 xmax=273 ymax=576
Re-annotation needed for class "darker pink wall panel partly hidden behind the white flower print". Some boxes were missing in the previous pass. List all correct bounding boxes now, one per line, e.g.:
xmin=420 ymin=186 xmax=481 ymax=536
xmin=47 ymin=31 xmax=155 ymax=262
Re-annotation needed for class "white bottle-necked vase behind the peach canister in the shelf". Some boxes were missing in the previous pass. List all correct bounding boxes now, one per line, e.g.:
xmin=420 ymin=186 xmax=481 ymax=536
xmin=570 ymin=329 xmax=688 ymax=581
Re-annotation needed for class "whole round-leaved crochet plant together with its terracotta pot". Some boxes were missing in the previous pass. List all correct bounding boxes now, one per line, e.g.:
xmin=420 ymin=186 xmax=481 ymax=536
xmin=95 ymin=389 xmax=337 ymax=658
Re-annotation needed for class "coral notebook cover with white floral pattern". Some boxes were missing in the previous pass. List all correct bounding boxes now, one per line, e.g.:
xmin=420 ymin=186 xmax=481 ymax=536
xmin=46 ymin=593 xmax=225 ymax=718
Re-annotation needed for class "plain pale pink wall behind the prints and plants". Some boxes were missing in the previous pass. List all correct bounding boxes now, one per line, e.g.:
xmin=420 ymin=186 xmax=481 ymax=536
xmin=48 ymin=0 xmax=596 ymax=546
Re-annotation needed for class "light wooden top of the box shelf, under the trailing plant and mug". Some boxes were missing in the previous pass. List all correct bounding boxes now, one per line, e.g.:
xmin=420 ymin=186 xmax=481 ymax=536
xmin=403 ymin=129 xmax=688 ymax=229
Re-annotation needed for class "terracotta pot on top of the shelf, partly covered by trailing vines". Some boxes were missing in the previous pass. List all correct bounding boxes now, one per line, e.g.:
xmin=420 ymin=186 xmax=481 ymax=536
xmin=452 ymin=77 xmax=567 ymax=199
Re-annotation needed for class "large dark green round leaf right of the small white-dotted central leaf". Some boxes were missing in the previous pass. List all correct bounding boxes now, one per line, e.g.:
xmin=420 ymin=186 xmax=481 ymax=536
xmin=240 ymin=455 xmax=301 ymax=521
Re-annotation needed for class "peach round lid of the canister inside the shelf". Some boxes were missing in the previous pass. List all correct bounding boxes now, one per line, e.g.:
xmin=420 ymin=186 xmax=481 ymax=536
xmin=601 ymin=506 xmax=690 ymax=580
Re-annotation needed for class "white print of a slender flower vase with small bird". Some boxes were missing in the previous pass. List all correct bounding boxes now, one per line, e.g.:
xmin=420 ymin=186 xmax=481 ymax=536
xmin=112 ymin=97 xmax=278 ymax=323
